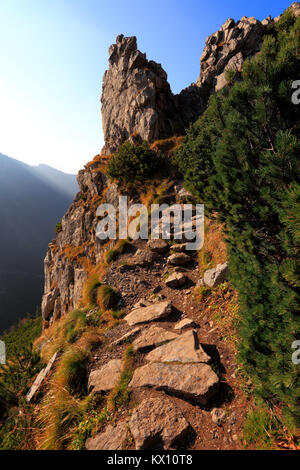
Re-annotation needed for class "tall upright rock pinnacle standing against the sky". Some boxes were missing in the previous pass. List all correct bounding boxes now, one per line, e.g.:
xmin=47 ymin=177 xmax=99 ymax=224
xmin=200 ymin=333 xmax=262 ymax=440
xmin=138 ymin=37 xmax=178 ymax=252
xmin=101 ymin=34 xmax=184 ymax=154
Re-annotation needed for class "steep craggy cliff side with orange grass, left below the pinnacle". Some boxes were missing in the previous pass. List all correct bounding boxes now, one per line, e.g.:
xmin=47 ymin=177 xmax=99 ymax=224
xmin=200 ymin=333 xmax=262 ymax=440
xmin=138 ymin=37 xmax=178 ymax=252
xmin=42 ymin=159 xmax=127 ymax=327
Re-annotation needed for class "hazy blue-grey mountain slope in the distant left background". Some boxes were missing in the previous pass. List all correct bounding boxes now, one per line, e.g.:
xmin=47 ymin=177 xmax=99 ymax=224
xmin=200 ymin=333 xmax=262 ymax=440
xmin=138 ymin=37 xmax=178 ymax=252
xmin=0 ymin=153 xmax=78 ymax=331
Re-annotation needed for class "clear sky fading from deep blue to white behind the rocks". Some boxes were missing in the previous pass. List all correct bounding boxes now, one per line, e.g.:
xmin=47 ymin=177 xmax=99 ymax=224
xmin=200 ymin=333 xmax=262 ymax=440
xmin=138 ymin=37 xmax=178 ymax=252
xmin=0 ymin=0 xmax=292 ymax=172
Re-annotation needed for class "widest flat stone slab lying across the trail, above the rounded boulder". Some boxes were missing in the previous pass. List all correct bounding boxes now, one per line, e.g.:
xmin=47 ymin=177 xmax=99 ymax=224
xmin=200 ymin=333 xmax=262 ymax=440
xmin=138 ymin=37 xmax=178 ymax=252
xmin=129 ymin=362 xmax=219 ymax=405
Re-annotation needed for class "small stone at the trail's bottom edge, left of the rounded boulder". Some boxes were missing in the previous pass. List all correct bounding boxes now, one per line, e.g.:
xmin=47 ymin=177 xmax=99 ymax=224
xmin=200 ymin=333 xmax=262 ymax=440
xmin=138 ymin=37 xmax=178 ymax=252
xmin=85 ymin=421 xmax=127 ymax=450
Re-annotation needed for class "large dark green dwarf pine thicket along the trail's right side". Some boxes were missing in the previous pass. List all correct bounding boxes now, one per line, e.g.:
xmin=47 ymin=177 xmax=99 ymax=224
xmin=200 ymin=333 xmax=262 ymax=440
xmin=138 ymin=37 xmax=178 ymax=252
xmin=177 ymin=12 xmax=300 ymax=424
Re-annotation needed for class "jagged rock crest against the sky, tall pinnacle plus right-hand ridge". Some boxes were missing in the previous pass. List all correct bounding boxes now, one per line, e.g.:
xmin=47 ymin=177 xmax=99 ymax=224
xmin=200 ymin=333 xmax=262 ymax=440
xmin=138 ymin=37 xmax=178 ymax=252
xmin=101 ymin=13 xmax=272 ymax=154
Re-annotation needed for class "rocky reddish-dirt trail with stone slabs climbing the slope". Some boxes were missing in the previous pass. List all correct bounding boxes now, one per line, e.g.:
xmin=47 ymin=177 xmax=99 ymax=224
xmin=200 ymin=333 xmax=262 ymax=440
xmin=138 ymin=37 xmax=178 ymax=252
xmin=81 ymin=235 xmax=246 ymax=449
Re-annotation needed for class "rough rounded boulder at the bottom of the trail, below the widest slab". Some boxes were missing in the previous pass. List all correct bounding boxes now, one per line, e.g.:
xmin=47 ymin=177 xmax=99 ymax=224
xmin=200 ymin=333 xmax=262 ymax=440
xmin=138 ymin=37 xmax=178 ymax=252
xmin=129 ymin=394 xmax=190 ymax=450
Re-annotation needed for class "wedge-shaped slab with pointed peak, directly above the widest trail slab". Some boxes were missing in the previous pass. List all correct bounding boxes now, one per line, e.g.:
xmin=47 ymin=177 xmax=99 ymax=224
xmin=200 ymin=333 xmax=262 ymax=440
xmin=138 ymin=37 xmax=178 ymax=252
xmin=146 ymin=330 xmax=210 ymax=363
